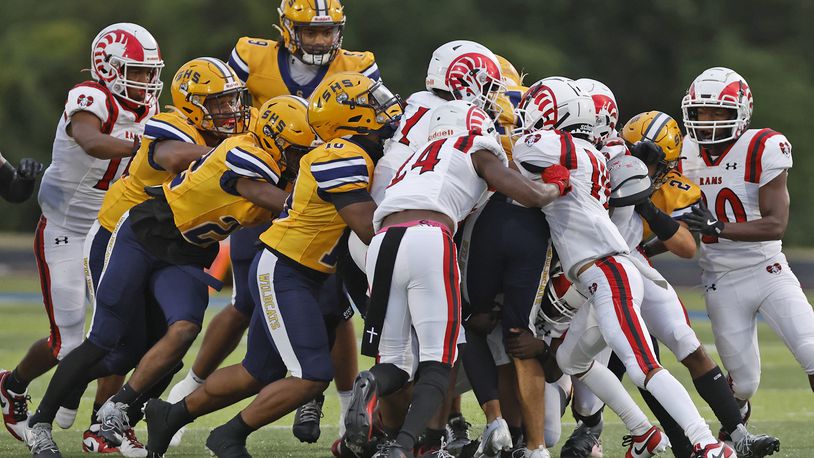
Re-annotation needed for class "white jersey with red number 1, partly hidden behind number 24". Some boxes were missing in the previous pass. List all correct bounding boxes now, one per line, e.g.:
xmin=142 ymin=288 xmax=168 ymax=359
xmin=370 ymin=91 xmax=446 ymax=203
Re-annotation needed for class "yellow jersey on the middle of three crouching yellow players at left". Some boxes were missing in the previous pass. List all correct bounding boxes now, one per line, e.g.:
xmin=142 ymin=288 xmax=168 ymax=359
xmin=163 ymin=133 xmax=280 ymax=247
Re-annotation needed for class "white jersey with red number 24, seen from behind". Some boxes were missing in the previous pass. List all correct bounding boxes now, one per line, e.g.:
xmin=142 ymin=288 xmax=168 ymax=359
xmin=373 ymin=135 xmax=508 ymax=232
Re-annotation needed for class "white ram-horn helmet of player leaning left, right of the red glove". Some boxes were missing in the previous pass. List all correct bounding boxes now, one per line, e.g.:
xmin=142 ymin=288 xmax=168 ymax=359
xmin=514 ymin=76 xmax=596 ymax=141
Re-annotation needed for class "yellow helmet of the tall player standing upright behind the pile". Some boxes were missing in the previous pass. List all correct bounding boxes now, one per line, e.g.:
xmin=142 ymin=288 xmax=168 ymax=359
xmin=277 ymin=0 xmax=345 ymax=65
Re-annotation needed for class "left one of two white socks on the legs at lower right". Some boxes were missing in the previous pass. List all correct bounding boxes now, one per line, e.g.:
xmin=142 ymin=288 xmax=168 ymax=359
xmin=579 ymin=362 xmax=653 ymax=436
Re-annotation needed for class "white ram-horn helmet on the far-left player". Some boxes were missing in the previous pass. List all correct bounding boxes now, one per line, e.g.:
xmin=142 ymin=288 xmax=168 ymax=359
xmin=90 ymin=22 xmax=164 ymax=105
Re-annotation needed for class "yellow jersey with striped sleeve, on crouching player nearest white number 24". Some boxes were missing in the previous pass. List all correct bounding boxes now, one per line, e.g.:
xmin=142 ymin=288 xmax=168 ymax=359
xmin=260 ymin=138 xmax=374 ymax=273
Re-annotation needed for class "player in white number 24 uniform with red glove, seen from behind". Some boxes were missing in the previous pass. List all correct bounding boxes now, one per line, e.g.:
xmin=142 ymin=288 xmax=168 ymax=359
xmin=345 ymin=101 xmax=569 ymax=457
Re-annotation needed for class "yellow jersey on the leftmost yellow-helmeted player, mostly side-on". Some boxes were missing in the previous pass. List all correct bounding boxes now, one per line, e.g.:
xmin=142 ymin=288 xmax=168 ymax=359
xmin=98 ymin=111 xmax=206 ymax=232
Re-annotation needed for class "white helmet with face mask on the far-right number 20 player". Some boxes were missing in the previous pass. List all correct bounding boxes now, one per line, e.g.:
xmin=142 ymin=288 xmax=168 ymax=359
xmin=681 ymin=67 xmax=753 ymax=145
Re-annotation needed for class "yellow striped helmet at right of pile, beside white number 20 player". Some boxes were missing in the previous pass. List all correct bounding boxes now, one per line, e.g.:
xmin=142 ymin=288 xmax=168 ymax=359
xmin=622 ymin=111 xmax=682 ymax=189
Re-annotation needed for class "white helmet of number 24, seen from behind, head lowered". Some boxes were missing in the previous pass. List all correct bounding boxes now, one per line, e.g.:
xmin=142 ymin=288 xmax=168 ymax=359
xmin=427 ymin=100 xmax=500 ymax=142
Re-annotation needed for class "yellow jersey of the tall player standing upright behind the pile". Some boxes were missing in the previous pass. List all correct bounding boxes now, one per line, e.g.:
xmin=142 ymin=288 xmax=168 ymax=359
xmin=229 ymin=37 xmax=381 ymax=108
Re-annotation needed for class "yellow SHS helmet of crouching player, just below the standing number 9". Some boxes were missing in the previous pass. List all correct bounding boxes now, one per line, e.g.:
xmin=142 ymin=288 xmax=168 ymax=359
xmin=308 ymin=72 xmax=402 ymax=142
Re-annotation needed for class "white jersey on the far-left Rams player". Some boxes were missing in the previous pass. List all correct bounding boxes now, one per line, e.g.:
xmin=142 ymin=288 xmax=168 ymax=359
xmin=38 ymin=81 xmax=158 ymax=235
